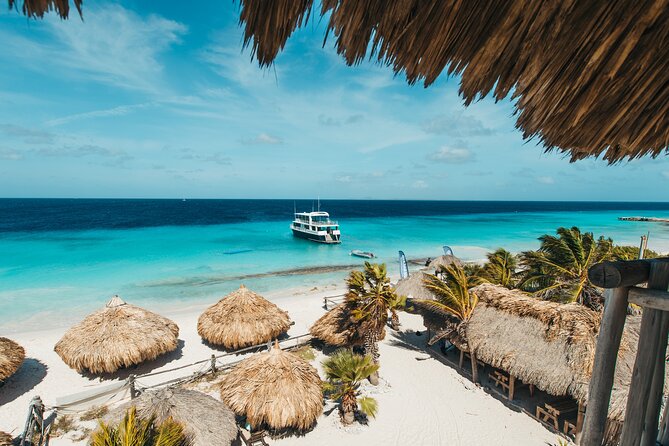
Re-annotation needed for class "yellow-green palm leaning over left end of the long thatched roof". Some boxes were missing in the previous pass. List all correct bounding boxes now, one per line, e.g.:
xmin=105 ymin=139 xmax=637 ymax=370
xmin=421 ymin=263 xmax=481 ymax=322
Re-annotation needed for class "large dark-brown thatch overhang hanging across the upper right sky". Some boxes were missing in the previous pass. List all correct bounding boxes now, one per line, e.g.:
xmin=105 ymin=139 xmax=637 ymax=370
xmin=240 ymin=0 xmax=669 ymax=162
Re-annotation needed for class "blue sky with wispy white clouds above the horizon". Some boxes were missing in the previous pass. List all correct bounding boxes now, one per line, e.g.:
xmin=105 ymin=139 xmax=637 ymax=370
xmin=0 ymin=1 xmax=669 ymax=201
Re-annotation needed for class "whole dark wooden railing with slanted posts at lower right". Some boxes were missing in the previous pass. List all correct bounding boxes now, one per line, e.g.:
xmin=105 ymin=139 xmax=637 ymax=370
xmin=577 ymin=259 xmax=669 ymax=446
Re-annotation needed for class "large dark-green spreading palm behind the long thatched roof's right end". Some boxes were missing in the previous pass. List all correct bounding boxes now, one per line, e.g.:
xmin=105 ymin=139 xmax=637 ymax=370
xmin=520 ymin=227 xmax=613 ymax=306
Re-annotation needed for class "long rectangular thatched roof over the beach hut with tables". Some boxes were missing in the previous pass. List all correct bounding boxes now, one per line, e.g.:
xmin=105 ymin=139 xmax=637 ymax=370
xmin=414 ymin=284 xmax=640 ymax=421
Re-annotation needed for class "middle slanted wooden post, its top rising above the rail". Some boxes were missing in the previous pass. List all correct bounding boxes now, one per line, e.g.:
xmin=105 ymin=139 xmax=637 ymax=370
xmin=620 ymin=260 xmax=669 ymax=446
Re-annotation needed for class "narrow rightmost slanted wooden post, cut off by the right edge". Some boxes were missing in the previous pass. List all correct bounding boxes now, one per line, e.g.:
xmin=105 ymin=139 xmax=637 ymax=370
xmin=641 ymin=312 xmax=669 ymax=446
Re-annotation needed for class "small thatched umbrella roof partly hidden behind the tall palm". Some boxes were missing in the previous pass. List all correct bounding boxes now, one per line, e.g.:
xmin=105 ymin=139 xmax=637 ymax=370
xmin=309 ymin=303 xmax=386 ymax=347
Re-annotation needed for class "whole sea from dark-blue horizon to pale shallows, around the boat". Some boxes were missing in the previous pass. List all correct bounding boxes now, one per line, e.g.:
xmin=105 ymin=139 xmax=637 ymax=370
xmin=0 ymin=199 xmax=669 ymax=334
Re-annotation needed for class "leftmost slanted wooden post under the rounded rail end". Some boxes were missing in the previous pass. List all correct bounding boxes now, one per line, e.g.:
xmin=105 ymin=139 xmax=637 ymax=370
xmin=581 ymin=288 xmax=629 ymax=446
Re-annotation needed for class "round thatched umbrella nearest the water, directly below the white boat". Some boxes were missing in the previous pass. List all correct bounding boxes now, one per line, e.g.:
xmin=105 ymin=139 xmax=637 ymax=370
xmin=197 ymin=285 xmax=290 ymax=350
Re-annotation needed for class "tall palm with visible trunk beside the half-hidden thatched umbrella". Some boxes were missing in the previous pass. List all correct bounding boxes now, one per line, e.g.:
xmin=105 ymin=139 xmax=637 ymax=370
xmin=346 ymin=262 xmax=401 ymax=385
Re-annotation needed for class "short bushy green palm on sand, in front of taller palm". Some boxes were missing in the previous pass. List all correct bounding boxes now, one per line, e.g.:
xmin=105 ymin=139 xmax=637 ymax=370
xmin=323 ymin=349 xmax=379 ymax=424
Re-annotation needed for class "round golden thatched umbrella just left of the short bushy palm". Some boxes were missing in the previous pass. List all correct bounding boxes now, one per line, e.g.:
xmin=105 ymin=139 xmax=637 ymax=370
xmin=221 ymin=344 xmax=323 ymax=431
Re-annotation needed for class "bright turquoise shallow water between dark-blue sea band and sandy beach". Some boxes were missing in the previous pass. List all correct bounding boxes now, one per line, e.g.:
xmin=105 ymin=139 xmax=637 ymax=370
xmin=0 ymin=206 xmax=669 ymax=332
